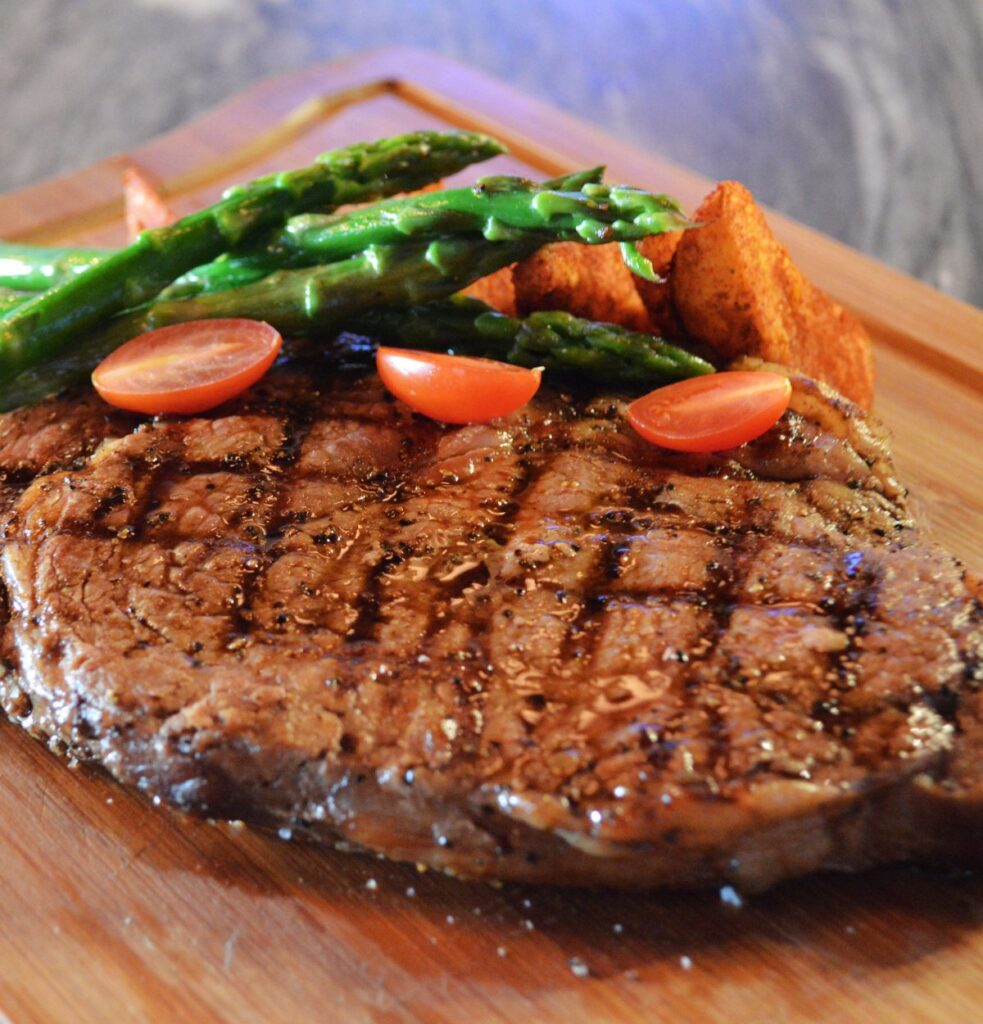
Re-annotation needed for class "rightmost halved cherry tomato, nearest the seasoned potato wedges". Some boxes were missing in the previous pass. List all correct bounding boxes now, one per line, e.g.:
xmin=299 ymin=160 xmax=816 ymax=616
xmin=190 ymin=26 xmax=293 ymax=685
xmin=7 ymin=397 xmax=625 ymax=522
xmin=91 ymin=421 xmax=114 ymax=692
xmin=628 ymin=370 xmax=792 ymax=452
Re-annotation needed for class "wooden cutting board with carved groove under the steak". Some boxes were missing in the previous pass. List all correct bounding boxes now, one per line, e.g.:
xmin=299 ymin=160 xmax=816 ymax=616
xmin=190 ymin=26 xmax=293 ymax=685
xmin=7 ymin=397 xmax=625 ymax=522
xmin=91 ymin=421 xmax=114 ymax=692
xmin=0 ymin=50 xmax=983 ymax=1024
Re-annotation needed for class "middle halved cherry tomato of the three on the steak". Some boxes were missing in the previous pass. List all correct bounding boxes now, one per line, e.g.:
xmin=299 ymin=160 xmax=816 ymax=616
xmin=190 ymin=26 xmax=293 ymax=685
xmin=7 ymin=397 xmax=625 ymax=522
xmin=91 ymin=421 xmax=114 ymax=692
xmin=376 ymin=346 xmax=543 ymax=423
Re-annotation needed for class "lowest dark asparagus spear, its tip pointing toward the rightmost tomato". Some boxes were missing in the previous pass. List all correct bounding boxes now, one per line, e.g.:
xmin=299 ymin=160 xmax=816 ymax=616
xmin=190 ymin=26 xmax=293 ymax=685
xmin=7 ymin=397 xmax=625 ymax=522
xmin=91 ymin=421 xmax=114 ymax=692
xmin=345 ymin=295 xmax=714 ymax=386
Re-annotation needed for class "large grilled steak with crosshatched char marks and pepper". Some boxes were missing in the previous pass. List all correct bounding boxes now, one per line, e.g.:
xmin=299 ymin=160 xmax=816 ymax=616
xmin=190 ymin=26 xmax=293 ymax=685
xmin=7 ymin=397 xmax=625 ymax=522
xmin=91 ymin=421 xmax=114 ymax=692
xmin=0 ymin=360 xmax=983 ymax=889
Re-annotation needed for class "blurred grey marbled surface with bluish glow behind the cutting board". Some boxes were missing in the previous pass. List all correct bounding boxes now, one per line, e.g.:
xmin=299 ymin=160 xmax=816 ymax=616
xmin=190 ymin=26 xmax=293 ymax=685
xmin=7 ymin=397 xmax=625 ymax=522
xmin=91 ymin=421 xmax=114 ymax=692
xmin=0 ymin=0 xmax=983 ymax=304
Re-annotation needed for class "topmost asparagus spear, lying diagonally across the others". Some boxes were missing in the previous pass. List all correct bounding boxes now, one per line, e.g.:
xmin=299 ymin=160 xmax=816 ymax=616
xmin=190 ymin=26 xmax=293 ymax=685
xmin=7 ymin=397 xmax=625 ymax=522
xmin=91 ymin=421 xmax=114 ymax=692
xmin=0 ymin=132 xmax=502 ymax=381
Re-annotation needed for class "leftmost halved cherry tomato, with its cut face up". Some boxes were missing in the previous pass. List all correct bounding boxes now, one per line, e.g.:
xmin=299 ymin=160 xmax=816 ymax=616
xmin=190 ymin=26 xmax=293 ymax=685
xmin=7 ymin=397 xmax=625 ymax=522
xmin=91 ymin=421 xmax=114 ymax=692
xmin=92 ymin=319 xmax=284 ymax=415
